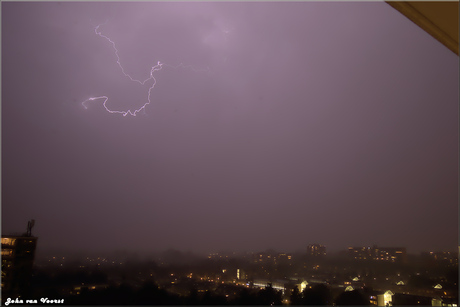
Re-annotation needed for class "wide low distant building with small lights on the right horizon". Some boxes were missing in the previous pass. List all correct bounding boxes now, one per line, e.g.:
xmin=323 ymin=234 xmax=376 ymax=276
xmin=348 ymin=245 xmax=407 ymax=263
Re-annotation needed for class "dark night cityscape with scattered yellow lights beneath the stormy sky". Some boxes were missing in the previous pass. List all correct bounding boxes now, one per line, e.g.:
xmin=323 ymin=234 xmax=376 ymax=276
xmin=2 ymin=236 xmax=458 ymax=306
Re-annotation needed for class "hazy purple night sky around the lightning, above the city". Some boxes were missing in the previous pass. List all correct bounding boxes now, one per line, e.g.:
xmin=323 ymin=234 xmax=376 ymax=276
xmin=2 ymin=2 xmax=459 ymax=252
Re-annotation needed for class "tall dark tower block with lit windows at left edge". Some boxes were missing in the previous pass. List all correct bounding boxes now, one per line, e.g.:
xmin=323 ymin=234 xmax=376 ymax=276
xmin=1 ymin=220 xmax=38 ymax=298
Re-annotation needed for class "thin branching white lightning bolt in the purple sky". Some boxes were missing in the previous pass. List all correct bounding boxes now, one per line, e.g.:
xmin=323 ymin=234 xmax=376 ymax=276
xmin=82 ymin=24 xmax=210 ymax=116
